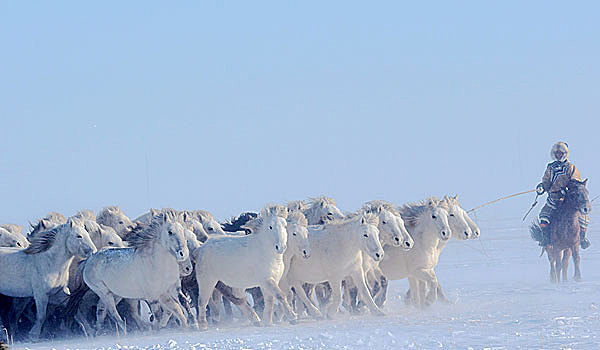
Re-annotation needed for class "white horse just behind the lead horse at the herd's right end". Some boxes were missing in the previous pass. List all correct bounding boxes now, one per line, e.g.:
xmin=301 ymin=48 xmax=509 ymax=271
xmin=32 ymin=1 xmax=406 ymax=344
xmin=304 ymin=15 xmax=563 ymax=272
xmin=379 ymin=198 xmax=452 ymax=305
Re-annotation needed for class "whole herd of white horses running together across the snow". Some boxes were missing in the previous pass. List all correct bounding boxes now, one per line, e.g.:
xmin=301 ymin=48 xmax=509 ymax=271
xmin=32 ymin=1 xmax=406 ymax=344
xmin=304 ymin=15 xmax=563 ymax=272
xmin=0 ymin=196 xmax=479 ymax=340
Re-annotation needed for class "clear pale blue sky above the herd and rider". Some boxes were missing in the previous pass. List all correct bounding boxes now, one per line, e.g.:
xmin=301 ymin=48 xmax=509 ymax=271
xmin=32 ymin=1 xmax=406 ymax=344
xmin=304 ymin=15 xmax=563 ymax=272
xmin=0 ymin=1 xmax=600 ymax=224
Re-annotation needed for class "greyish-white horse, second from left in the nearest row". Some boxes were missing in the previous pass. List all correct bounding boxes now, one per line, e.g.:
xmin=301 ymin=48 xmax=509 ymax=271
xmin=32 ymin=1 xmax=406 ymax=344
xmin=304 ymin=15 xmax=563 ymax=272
xmin=83 ymin=214 xmax=189 ymax=332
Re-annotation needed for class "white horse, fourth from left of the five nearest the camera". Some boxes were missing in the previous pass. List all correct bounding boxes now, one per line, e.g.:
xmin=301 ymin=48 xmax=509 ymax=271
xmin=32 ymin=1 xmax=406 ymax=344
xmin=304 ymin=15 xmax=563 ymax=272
xmin=286 ymin=213 xmax=384 ymax=318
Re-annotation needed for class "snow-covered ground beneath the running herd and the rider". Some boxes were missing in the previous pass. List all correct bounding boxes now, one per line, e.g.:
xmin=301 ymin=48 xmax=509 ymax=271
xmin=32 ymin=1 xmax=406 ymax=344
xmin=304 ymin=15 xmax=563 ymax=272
xmin=15 ymin=218 xmax=600 ymax=349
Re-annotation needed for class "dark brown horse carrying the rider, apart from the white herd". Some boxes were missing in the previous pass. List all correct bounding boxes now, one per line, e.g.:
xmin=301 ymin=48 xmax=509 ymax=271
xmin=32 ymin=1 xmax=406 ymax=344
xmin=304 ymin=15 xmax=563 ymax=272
xmin=531 ymin=179 xmax=592 ymax=283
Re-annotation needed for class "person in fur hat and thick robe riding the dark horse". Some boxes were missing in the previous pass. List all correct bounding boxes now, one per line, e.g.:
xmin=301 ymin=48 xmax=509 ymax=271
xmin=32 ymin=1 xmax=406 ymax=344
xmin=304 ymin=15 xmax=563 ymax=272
xmin=536 ymin=142 xmax=591 ymax=249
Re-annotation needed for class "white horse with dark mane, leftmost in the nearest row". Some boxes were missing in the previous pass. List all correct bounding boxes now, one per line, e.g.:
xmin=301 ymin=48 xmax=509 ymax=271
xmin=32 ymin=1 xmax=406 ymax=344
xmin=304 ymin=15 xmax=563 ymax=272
xmin=0 ymin=219 xmax=96 ymax=339
